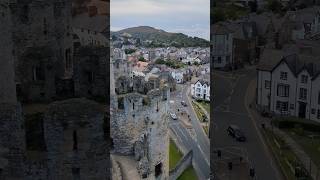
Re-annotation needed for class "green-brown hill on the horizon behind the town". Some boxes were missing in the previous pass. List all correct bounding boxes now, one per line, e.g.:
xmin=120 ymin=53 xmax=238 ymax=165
xmin=112 ymin=26 xmax=209 ymax=47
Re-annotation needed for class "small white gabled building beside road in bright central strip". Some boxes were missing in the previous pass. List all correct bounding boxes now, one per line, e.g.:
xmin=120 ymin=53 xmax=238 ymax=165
xmin=191 ymin=79 xmax=210 ymax=101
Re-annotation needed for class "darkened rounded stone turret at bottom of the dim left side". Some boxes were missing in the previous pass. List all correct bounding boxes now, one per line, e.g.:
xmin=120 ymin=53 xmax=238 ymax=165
xmin=44 ymin=99 xmax=109 ymax=180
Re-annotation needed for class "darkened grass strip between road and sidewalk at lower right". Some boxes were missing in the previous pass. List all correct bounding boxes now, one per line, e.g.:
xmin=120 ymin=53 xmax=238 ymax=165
xmin=263 ymin=129 xmax=308 ymax=180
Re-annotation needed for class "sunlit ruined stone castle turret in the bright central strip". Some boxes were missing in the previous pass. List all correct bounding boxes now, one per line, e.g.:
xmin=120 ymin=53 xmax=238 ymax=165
xmin=111 ymin=56 xmax=170 ymax=179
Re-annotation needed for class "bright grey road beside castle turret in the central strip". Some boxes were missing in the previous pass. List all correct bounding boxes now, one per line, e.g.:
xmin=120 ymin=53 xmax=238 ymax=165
xmin=170 ymin=84 xmax=210 ymax=179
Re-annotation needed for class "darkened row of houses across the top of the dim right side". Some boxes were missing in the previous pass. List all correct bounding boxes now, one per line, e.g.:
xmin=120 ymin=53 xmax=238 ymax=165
xmin=211 ymin=6 xmax=320 ymax=69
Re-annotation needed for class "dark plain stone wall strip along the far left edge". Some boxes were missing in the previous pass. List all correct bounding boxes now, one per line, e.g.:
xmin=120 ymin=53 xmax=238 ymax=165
xmin=0 ymin=1 xmax=26 ymax=180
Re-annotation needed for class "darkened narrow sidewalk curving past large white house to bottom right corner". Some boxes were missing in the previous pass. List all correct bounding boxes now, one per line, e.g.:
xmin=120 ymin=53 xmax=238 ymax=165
xmin=248 ymin=79 xmax=320 ymax=180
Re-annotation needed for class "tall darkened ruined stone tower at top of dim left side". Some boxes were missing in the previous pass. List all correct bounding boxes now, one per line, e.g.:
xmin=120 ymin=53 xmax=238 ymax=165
xmin=10 ymin=0 xmax=73 ymax=101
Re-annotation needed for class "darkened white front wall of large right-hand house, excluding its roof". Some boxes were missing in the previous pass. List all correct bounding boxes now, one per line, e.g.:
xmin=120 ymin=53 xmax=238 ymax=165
xmin=257 ymin=61 xmax=320 ymax=122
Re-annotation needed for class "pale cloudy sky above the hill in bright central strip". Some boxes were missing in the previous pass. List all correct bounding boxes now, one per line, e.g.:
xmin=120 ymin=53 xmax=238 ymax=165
xmin=110 ymin=0 xmax=210 ymax=40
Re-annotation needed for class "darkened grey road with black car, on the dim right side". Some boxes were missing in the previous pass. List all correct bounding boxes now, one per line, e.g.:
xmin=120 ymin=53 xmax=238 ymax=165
xmin=211 ymin=69 xmax=281 ymax=180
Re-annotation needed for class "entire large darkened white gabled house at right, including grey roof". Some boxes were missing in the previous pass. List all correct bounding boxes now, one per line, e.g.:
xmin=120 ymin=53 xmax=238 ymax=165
xmin=257 ymin=50 xmax=320 ymax=122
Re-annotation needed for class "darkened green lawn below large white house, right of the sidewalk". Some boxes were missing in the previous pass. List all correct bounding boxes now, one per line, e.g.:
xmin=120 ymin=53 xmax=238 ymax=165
xmin=286 ymin=129 xmax=320 ymax=167
